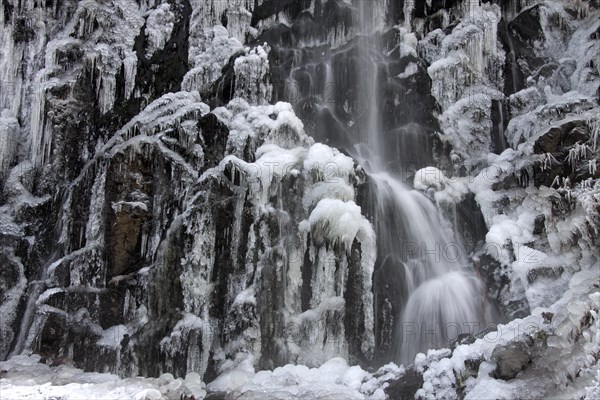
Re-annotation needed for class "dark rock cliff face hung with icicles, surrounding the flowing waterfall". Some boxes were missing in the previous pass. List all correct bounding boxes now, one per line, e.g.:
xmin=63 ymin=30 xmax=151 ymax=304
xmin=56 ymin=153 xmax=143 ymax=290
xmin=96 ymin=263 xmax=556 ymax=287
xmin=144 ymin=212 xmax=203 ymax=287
xmin=0 ymin=0 xmax=600 ymax=395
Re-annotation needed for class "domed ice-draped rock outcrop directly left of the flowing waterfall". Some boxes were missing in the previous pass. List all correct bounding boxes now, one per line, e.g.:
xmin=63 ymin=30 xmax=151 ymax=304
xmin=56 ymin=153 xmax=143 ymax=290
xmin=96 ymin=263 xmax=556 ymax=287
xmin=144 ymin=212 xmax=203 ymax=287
xmin=1 ymin=89 xmax=375 ymax=377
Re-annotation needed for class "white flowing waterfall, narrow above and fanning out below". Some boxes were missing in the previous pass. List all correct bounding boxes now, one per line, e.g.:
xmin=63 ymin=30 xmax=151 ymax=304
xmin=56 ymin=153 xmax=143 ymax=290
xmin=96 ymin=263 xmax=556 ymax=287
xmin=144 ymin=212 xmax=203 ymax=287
xmin=354 ymin=1 xmax=487 ymax=364
